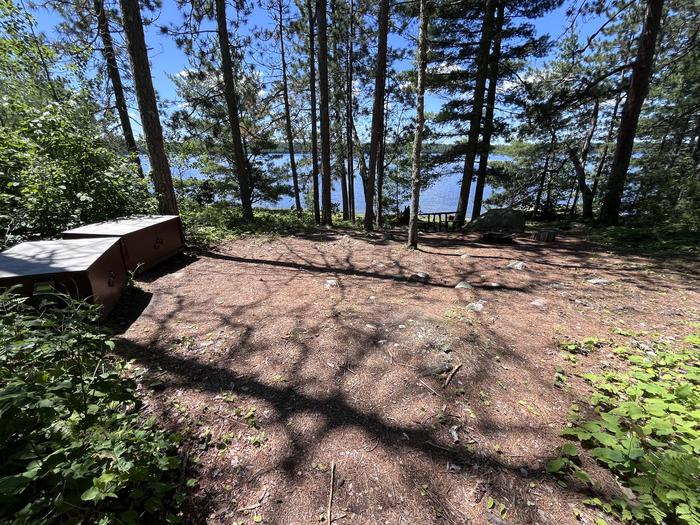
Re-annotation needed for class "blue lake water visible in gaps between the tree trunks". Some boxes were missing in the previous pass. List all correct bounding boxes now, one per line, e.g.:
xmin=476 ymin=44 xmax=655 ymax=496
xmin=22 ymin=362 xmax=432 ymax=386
xmin=171 ymin=154 xmax=496 ymax=217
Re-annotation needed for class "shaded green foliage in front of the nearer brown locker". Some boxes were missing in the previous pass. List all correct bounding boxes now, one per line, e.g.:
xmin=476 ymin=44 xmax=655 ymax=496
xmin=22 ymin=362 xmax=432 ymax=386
xmin=0 ymin=292 xmax=182 ymax=524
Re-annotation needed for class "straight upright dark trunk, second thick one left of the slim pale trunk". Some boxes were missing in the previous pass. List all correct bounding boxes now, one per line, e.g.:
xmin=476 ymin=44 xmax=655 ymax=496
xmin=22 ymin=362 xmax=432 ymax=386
xmin=316 ymin=0 xmax=333 ymax=226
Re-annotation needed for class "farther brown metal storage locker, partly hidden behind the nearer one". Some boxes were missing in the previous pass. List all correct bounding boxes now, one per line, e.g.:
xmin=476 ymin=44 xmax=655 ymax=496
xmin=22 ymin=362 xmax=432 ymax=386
xmin=62 ymin=215 xmax=185 ymax=271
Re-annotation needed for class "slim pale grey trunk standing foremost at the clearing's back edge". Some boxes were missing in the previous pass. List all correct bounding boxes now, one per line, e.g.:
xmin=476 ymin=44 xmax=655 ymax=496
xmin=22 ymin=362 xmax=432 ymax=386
xmin=408 ymin=0 xmax=428 ymax=248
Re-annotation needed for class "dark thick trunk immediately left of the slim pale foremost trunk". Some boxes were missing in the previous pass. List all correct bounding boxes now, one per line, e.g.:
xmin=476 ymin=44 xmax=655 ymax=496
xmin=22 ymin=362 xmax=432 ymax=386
xmin=364 ymin=0 xmax=391 ymax=231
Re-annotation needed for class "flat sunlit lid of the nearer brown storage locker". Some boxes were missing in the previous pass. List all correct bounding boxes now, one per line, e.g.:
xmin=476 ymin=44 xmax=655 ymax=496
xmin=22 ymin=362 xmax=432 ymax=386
xmin=0 ymin=237 xmax=119 ymax=278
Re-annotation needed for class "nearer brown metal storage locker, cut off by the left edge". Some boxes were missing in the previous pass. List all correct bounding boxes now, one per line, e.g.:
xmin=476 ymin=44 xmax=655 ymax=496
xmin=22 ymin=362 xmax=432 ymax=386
xmin=0 ymin=237 xmax=127 ymax=315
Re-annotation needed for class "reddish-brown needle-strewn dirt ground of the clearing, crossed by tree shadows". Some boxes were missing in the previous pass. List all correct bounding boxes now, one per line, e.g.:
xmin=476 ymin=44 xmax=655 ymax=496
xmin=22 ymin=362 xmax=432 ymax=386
xmin=112 ymin=231 xmax=700 ymax=525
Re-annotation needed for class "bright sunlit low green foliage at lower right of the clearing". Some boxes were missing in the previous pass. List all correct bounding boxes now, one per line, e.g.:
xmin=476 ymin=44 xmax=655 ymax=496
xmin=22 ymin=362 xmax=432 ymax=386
xmin=547 ymin=334 xmax=700 ymax=525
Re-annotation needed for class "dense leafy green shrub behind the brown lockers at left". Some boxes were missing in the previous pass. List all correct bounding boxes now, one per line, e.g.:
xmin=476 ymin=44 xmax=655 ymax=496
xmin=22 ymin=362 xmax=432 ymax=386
xmin=0 ymin=100 xmax=154 ymax=247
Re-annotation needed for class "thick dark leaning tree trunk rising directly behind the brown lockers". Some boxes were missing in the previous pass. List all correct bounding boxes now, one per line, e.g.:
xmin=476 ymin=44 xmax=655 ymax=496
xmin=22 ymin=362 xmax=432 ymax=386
xmin=120 ymin=0 xmax=178 ymax=215
